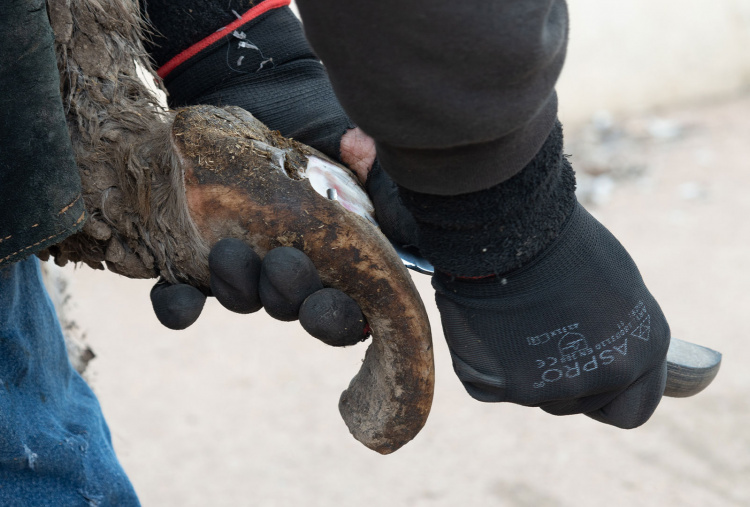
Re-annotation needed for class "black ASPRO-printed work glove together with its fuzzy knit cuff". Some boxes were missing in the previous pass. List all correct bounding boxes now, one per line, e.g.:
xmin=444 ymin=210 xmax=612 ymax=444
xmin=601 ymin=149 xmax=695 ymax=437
xmin=402 ymin=124 xmax=670 ymax=428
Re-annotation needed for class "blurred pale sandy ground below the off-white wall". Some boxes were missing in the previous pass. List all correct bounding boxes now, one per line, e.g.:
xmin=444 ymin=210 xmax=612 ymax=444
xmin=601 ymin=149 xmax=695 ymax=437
xmin=60 ymin=97 xmax=750 ymax=507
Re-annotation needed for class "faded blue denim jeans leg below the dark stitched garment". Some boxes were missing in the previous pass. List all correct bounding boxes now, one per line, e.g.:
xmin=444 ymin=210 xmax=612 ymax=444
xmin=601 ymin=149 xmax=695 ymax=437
xmin=0 ymin=257 xmax=140 ymax=507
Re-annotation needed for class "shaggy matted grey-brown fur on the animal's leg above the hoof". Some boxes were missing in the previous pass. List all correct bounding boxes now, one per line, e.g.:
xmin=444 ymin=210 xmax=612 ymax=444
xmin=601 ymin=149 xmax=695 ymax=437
xmin=40 ymin=0 xmax=208 ymax=286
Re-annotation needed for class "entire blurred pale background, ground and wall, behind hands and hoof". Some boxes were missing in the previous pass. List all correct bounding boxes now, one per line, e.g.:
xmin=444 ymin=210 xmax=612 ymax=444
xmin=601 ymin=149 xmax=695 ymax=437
xmin=45 ymin=0 xmax=750 ymax=507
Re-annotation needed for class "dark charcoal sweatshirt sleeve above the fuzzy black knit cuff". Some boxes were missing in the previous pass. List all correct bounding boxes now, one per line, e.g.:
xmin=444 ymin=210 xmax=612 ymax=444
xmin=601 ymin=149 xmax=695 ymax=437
xmin=297 ymin=0 xmax=568 ymax=195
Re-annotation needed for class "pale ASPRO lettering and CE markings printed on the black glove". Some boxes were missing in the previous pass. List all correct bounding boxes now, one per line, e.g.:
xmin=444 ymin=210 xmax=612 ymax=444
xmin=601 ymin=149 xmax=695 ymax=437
xmin=530 ymin=301 xmax=651 ymax=389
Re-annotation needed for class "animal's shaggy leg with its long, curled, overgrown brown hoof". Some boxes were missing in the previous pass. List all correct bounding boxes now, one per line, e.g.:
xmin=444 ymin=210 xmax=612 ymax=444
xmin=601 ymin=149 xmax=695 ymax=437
xmin=40 ymin=0 xmax=434 ymax=454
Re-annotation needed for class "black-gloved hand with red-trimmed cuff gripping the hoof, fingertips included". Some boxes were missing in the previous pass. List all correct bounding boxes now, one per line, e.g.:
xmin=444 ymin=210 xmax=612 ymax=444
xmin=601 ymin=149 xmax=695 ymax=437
xmin=146 ymin=0 xmax=413 ymax=345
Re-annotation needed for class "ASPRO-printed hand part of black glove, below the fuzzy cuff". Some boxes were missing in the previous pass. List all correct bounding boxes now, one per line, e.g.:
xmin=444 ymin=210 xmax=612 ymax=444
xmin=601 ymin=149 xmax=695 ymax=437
xmin=433 ymin=205 xmax=670 ymax=428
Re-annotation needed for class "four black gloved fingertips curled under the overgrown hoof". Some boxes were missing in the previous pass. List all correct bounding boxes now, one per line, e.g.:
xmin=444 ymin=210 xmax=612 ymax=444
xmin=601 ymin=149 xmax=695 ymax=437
xmin=151 ymin=238 xmax=366 ymax=346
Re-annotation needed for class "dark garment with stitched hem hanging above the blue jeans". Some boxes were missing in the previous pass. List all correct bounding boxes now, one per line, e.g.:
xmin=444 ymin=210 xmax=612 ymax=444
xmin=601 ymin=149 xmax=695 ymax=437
xmin=0 ymin=0 xmax=86 ymax=269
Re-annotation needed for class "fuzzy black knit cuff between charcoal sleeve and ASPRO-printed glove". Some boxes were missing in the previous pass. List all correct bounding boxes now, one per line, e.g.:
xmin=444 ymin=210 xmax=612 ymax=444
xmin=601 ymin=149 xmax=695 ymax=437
xmin=400 ymin=122 xmax=576 ymax=277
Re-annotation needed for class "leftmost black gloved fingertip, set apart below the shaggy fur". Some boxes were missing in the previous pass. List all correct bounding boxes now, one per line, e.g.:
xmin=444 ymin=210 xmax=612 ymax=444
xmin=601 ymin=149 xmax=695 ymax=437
xmin=151 ymin=283 xmax=206 ymax=331
